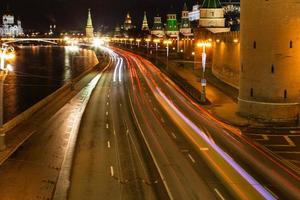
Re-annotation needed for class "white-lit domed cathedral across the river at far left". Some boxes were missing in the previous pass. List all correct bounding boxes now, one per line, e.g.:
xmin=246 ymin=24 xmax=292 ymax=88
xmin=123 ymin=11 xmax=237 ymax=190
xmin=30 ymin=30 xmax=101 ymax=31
xmin=0 ymin=12 xmax=24 ymax=37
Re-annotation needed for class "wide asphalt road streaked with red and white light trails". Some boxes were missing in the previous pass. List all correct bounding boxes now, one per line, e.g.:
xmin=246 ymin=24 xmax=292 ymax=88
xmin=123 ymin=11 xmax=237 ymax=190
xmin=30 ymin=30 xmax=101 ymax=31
xmin=0 ymin=46 xmax=300 ymax=200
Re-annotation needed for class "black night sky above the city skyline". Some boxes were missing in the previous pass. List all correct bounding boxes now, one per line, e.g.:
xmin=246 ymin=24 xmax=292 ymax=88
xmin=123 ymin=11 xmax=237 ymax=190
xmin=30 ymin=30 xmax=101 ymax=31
xmin=0 ymin=0 xmax=238 ymax=31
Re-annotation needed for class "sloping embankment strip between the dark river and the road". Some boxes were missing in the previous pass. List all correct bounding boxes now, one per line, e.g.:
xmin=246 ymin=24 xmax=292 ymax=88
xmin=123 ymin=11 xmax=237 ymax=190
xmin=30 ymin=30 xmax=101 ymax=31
xmin=0 ymin=48 xmax=109 ymax=165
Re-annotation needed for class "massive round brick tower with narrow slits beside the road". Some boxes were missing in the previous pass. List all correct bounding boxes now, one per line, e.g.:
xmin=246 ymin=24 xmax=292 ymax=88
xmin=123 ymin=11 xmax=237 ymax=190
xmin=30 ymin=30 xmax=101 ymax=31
xmin=239 ymin=0 xmax=300 ymax=122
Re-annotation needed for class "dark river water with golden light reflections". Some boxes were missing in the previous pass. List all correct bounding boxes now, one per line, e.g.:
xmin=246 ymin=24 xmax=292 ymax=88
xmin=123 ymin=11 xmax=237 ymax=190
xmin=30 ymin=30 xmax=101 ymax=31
xmin=4 ymin=46 xmax=97 ymax=122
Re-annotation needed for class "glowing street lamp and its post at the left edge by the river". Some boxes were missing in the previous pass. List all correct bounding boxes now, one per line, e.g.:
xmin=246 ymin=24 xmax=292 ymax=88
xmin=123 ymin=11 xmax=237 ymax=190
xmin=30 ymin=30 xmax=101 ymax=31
xmin=0 ymin=45 xmax=15 ymax=151
